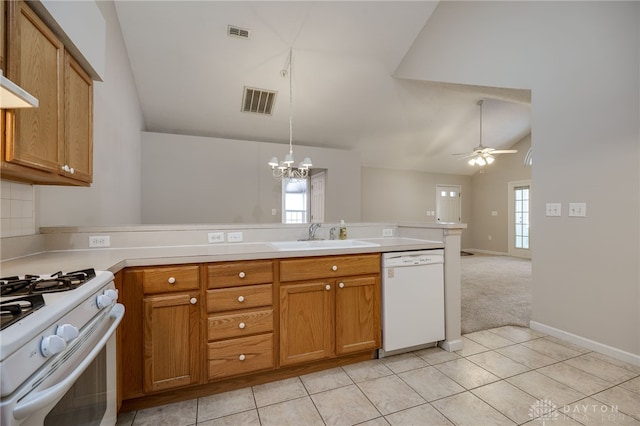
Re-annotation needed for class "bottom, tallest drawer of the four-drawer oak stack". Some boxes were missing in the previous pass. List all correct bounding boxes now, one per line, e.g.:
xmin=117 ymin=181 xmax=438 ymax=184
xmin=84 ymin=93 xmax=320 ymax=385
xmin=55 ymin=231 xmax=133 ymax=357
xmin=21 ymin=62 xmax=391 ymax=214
xmin=208 ymin=333 xmax=274 ymax=380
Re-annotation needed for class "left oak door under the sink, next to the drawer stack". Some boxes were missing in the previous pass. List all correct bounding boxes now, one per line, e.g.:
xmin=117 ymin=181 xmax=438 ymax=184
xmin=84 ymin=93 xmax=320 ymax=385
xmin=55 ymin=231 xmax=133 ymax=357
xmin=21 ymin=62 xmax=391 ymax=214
xmin=280 ymin=281 xmax=334 ymax=365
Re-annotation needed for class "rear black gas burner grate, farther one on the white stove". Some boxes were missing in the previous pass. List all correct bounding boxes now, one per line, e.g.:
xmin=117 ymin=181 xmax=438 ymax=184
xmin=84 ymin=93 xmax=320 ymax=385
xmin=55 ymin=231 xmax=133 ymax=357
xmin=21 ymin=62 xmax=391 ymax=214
xmin=0 ymin=268 xmax=96 ymax=296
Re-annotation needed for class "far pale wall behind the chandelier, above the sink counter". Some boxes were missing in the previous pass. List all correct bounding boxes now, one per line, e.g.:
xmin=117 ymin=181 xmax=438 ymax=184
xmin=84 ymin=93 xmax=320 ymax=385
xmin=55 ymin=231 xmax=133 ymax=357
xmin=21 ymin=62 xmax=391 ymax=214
xmin=141 ymin=132 xmax=361 ymax=224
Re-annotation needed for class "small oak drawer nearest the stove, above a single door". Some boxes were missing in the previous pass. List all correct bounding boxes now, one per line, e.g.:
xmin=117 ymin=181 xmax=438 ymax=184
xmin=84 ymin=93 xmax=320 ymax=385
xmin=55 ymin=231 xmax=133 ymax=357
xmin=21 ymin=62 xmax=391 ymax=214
xmin=142 ymin=265 xmax=200 ymax=293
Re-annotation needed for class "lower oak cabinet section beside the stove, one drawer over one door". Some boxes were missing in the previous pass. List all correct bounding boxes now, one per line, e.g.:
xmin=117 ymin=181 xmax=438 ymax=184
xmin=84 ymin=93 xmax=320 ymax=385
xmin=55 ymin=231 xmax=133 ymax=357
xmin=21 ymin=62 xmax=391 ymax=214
xmin=116 ymin=265 xmax=205 ymax=400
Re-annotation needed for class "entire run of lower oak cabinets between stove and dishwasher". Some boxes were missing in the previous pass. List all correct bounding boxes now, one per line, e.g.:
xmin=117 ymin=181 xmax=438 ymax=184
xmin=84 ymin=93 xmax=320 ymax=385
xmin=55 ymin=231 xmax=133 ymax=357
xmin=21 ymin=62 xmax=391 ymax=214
xmin=116 ymin=254 xmax=381 ymax=409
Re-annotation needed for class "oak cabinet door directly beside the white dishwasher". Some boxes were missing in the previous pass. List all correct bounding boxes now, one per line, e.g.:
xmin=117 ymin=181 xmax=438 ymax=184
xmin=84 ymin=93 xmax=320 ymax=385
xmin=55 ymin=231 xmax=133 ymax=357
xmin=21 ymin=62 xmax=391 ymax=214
xmin=336 ymin=277 xmax=381 ymax=355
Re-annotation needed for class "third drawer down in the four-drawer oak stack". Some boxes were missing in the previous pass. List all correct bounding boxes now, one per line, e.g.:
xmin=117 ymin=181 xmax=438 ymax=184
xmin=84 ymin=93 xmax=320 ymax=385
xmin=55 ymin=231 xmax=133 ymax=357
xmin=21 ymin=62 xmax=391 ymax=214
xmin=208 ymin=309 xmax=273 ymax=340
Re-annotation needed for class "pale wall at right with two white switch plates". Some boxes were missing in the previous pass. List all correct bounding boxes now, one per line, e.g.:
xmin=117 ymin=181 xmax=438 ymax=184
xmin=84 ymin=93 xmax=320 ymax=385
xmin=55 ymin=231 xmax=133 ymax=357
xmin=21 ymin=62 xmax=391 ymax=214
xmin=397 ymin=1 xmax=640 ymax=356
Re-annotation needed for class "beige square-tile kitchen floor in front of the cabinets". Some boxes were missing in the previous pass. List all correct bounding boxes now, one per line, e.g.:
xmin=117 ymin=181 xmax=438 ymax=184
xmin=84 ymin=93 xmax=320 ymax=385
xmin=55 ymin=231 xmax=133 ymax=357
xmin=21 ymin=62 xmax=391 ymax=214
xmin=118 ymin=326 xmax=640 ymax=426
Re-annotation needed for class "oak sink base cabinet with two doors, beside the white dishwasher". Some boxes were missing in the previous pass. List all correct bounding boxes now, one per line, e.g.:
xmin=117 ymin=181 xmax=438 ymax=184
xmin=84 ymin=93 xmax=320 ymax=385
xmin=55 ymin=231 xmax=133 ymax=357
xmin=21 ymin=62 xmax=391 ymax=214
xmin=280 ymin=255 xmax=381 ymax=366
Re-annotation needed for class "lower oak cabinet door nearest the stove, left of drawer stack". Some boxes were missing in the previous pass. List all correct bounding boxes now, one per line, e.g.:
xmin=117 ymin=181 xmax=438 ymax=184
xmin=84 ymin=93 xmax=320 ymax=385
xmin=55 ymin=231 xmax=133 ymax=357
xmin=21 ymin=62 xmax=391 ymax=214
xmin=143 ymin=292 xmax=203 ymax=392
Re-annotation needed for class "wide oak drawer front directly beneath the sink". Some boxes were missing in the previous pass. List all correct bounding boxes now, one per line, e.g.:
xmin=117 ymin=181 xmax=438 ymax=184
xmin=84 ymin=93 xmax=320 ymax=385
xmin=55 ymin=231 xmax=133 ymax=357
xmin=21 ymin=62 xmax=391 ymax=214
xmin=280 ymin=254 xmax=380 ymax=282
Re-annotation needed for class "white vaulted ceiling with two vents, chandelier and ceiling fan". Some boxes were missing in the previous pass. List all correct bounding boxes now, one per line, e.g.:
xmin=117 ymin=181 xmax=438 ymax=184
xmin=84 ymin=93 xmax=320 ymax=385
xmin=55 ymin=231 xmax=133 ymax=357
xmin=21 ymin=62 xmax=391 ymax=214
xmin=116 ymin=0 xmax=531 ymax=175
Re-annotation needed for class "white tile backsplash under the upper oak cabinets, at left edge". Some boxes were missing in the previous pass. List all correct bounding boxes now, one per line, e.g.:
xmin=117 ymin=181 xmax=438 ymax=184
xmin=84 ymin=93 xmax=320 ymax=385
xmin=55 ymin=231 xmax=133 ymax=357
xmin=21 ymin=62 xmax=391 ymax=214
xmin=0 ymin=181 xmax=36 ymax=237
